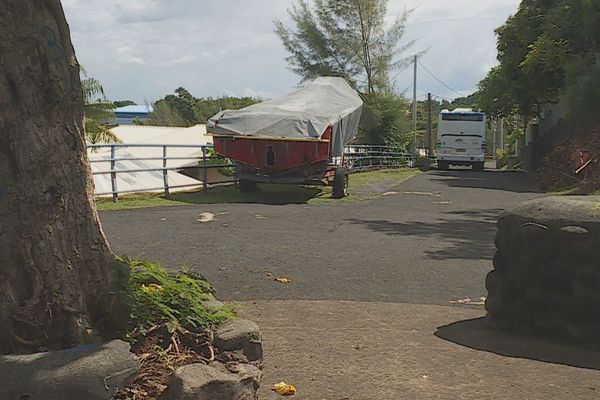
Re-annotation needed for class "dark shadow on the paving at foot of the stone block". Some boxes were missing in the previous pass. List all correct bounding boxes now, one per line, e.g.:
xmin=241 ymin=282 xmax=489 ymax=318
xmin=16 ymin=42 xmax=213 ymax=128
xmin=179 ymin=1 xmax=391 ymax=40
xmin=435 ymin=318 xmax=600 ymax=370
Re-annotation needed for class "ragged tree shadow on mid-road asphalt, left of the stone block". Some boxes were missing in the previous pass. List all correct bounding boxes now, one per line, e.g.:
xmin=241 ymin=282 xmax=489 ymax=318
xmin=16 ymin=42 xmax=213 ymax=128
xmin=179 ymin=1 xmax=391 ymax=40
xmin=348 ymin=209 xmax=503 ymax=260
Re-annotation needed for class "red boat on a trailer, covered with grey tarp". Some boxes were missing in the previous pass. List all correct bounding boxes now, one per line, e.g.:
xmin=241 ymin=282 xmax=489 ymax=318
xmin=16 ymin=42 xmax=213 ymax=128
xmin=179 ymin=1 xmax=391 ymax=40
xmin=206 ymin=77 xmax=363 ymax=198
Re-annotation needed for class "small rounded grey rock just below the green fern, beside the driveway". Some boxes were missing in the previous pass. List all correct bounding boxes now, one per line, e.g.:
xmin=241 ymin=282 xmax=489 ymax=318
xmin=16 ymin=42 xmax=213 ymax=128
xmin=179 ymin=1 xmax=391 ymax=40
xmin=213 ymin=319 xmax=263 ymax=362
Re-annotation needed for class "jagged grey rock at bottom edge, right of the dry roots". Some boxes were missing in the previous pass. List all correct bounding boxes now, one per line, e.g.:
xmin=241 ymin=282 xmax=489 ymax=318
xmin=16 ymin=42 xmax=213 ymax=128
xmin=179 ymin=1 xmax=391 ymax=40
xmin=159 ymin=364 xmax=262 ymax=400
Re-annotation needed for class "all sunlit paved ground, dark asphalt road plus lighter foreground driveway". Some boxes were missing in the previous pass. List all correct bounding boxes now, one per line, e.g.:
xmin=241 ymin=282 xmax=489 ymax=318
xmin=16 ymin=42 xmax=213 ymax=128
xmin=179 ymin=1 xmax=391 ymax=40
xmin=101 ymin=171 xmax=600 ymax=400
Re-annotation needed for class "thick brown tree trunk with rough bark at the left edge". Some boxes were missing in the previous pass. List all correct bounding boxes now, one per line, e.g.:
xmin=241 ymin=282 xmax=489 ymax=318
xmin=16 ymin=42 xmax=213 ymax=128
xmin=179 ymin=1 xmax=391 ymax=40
xmin=0 ymin=0 xmax=124 ymax=353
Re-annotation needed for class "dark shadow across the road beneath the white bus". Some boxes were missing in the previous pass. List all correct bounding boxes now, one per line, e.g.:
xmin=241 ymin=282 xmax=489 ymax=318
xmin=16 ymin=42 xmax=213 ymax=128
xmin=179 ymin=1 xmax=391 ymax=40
xmin=431 ymin=171 xmax=539 ymax=193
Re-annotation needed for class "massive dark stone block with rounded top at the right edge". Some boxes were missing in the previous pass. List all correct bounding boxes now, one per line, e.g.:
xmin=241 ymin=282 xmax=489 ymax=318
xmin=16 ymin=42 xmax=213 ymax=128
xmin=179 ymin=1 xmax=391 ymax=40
xmin=486 ymin=196 xmax=600 ymax=349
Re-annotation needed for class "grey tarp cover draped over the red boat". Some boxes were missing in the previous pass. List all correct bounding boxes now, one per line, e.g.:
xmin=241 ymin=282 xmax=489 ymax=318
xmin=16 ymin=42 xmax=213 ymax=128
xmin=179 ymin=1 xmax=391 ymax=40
xmin=206 ymin=77 xmax=363 ymax=156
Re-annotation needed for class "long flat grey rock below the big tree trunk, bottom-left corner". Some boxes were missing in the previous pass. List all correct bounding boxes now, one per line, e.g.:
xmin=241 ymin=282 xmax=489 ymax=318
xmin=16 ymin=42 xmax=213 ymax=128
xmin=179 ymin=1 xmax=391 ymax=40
xmin=0 ymin=340 xmax=140 ymax=400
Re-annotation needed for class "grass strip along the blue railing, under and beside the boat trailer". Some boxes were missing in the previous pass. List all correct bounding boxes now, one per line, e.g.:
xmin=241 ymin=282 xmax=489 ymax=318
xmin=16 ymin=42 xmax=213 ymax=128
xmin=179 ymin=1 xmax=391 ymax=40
xmin=96 ymin=169 xmax=420 ymax=210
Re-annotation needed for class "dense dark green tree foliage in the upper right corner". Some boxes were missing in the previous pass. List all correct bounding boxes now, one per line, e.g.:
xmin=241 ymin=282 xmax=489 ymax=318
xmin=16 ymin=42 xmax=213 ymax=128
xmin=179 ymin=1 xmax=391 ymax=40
xmin=479 ymin=0 xmax=600 ymax=127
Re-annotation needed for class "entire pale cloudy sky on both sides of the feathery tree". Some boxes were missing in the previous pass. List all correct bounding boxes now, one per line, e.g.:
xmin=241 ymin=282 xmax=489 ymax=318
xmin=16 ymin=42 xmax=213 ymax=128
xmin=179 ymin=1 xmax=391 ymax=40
xmin=62 ymin=0 xmax=520 ymax=104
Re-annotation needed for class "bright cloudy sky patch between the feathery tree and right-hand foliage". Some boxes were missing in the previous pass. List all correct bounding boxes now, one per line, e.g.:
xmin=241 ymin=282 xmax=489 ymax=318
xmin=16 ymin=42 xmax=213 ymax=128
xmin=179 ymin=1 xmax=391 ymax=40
xmin=390 ymin=0 xmax=520 ymax=98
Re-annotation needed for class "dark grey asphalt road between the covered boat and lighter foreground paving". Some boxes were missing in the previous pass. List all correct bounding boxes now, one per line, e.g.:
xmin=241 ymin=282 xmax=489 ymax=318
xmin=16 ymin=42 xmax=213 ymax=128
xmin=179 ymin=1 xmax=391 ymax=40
xmin=100 ymin=170 xmax=541 ymax=305
